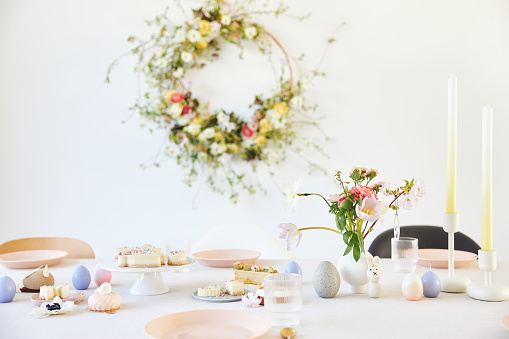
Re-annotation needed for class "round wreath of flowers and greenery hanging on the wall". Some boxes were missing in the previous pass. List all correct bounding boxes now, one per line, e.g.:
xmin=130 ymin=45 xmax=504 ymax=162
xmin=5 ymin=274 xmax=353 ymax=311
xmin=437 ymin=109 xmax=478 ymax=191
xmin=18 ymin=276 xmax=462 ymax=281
xmin=106 ymin=0 xmax=333 ymax=202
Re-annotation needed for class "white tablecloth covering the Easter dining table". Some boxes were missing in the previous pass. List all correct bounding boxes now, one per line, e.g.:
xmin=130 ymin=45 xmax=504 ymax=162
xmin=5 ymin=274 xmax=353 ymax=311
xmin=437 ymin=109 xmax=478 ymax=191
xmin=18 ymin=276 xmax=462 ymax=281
xmin=0 ymin=259 xmax=509 ymax=339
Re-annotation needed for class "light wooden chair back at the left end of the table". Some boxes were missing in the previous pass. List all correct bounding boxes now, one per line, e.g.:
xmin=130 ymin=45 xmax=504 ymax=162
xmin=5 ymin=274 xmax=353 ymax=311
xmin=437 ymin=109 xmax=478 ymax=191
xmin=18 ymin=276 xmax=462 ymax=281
xmin=0 ymin=237 xmax=95 ymax=259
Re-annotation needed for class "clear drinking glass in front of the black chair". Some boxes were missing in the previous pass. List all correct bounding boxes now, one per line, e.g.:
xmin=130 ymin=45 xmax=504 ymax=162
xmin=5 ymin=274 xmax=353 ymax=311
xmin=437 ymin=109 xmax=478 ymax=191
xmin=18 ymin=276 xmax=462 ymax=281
xmin=391 ymin=237 xmax=419 ymax=272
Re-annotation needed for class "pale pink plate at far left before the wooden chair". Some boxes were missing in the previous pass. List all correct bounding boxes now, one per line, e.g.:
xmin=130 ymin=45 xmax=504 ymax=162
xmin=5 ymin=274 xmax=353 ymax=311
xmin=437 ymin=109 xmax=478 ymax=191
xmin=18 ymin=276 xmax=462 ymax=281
xmin=0 ymin=250 xmax=67 ymax=268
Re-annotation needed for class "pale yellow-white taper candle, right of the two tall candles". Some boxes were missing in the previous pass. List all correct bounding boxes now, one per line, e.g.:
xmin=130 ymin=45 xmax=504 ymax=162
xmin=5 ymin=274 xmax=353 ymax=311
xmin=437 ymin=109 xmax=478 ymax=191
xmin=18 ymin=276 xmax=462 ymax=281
xmin=481 ymin=105 xmax=493 ymax=251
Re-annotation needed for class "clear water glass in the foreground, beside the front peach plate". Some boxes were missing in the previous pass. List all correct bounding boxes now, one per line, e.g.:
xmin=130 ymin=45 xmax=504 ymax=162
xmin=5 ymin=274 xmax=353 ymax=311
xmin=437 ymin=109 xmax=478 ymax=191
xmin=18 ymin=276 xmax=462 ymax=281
xmin=264 ymin=273 xmax=302 ymax=327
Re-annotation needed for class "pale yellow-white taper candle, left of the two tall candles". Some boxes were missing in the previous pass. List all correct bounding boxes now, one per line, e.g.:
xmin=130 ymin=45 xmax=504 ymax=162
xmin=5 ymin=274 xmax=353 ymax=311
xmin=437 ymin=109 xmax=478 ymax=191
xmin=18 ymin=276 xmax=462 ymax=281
xmin=445 ymin=75 xmax=458 ymax=213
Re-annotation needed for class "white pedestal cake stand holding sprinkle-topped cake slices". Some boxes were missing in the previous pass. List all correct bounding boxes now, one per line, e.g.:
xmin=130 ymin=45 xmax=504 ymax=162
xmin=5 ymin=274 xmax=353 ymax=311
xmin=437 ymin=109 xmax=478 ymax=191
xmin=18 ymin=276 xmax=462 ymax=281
xmin=101 ymin=257 xmax=196 ymax=295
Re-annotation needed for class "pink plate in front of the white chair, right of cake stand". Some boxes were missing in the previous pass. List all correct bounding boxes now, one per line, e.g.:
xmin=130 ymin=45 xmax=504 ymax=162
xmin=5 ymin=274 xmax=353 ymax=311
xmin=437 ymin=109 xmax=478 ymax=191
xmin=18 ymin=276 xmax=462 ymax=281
xmin=193 ymin=250 xmax=262 ymax=268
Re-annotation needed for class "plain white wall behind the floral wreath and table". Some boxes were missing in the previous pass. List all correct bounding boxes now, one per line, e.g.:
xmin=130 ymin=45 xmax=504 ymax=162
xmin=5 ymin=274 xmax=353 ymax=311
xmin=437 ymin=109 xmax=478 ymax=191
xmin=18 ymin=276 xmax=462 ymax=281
xmin=0 ymin=0 xmax=509 ymax=257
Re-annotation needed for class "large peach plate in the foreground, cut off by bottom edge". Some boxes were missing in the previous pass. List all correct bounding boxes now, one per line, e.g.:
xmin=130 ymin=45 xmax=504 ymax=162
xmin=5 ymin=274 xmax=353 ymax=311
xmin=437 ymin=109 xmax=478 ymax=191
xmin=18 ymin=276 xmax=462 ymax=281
xmin=145 ymin=309 xmax=270 ymax=339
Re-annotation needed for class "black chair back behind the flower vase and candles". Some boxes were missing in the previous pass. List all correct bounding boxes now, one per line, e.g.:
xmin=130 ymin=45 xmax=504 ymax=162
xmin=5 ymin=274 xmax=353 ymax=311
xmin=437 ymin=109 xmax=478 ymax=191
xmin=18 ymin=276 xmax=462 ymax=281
xmin=368 ymin=225 xmax=481 ymax=258
